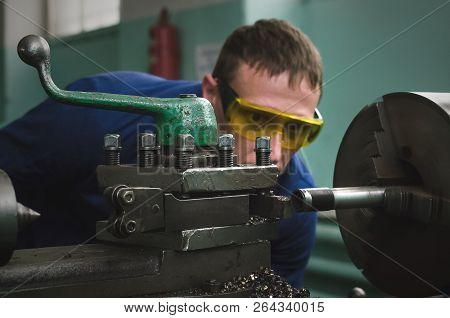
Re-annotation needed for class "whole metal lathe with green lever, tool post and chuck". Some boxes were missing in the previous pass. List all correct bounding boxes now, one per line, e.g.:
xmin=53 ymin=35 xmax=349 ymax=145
xmin=0 ymin=35 xmax=450 ymax=297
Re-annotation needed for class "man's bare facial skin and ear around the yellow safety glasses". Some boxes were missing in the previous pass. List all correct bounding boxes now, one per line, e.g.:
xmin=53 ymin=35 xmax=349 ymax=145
xmin=203 ymin=64 xmax=320 ymax=171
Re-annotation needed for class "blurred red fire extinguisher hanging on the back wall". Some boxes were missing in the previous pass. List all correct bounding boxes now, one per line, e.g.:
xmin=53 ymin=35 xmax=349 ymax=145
xmin=149 ymin=8 xmax=180 ymax=79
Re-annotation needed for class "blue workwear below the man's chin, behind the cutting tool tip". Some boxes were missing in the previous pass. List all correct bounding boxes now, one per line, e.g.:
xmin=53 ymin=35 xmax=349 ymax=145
xmin=272 ymin=154 xmax=317 ymax=288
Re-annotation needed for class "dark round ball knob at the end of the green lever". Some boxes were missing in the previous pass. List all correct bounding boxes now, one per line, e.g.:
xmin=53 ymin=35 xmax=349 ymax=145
xmin=17 ymin=34 xmax=50 ymax=67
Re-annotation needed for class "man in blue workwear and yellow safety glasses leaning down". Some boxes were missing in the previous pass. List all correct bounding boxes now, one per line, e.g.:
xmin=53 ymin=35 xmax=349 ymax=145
xmin=0 ymin=20 xmax=322 ymax=287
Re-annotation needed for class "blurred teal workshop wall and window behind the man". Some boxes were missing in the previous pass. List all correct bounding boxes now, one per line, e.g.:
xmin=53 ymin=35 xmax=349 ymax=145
xmin=0 ymin=0 xmax=450 ymax=297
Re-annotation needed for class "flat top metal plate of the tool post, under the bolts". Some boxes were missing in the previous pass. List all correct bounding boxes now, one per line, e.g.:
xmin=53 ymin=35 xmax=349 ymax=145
xmin=97 ymin=165 xmax=279 ymax=193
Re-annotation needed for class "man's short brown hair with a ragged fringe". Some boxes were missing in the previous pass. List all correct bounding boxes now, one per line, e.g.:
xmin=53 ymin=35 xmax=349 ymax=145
xmin=213 ymin=19 xmax=322 ymax=89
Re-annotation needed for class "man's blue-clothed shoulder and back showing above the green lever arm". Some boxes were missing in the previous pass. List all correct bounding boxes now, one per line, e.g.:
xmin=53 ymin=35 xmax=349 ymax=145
xmin=67 ymin=71 xmax=201 ymax=97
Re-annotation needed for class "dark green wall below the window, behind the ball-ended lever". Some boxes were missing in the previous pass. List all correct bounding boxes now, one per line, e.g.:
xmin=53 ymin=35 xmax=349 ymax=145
xmin=0 ymin=27 xmax=119 ymax=125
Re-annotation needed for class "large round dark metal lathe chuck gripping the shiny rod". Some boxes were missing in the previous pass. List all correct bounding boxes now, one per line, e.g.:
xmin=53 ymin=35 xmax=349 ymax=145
xmin=333 ymin=93 xmax=450 ymax=297
